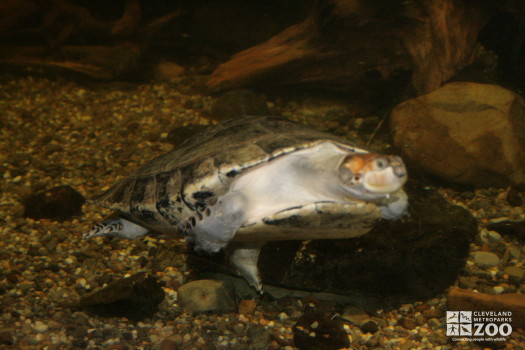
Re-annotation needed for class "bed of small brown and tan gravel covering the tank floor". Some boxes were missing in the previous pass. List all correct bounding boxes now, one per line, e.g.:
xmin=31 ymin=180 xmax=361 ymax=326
xmin=0 ymin=76 xmax=525 ymax=350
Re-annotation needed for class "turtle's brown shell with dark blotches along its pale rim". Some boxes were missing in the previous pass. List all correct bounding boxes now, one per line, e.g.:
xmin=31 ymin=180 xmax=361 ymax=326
xmin=93 ymin=117 xmax=372 ymax=240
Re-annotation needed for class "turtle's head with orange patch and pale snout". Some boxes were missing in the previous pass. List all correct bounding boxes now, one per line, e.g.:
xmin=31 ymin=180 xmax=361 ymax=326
xmin=339 ymin=153 xmax=407 ymax=200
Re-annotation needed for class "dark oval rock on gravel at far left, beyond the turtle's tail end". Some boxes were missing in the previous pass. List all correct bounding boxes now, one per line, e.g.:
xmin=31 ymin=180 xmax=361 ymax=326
xmin=23 ymin=186 xmax=86 ymax=220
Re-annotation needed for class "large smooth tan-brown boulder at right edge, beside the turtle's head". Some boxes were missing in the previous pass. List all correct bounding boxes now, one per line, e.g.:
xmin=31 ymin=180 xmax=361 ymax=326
xmin=391 ymin=82 xmax=525 ymax=186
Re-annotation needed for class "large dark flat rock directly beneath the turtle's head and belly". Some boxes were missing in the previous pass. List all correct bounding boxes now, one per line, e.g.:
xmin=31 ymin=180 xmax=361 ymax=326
xmin=189 ymin=183 xmax=477 ymax=307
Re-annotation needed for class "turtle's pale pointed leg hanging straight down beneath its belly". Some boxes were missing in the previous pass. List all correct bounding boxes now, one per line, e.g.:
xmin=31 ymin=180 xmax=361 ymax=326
xmin=225 ymin=242 xmax=266 ymax=294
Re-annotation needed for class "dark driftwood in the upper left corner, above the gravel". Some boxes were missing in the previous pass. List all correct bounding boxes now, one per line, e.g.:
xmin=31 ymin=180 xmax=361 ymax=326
xmin=0 ymin=0 xmax=180 ymax=79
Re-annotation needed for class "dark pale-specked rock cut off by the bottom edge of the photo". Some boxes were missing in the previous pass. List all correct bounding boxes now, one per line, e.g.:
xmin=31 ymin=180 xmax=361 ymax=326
xmin=293 ymin=312 xmax=350 ymax=350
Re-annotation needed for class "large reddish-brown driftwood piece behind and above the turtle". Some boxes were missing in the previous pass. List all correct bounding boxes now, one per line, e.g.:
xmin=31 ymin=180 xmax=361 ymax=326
xmin=207 ymin=0 xmax=490 ymax=93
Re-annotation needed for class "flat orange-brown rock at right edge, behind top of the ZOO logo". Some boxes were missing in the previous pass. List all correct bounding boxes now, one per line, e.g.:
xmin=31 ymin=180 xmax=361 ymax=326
xmin=447 ymin=287 xmax=525 ymax=328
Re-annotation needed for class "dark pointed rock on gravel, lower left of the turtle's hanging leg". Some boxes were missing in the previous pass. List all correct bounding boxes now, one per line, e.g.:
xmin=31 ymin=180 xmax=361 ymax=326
xmin=78 ymin=272 xmax=165 ymax=321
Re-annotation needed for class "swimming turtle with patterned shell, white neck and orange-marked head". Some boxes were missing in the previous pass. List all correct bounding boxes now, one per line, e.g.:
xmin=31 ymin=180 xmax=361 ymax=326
xmin=84 ymin=116 xmax=408 ymax=293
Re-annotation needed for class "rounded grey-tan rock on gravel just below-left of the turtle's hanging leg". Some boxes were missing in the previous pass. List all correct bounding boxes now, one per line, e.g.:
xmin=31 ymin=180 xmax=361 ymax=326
xmin=177 ymin=280 xmax=237 ymax=313
